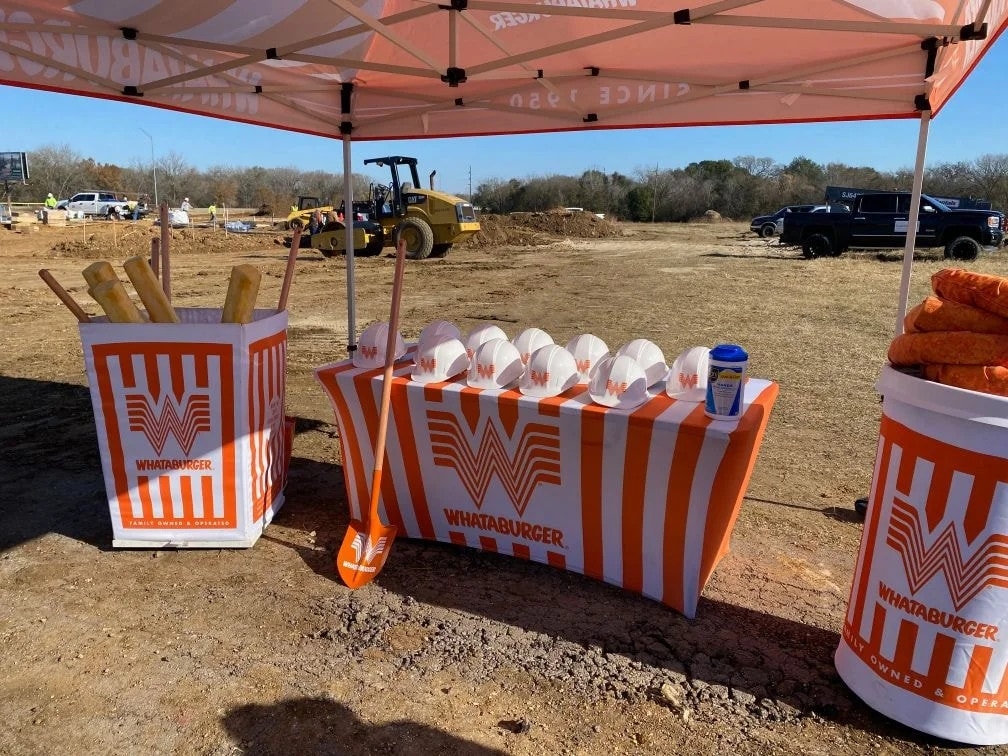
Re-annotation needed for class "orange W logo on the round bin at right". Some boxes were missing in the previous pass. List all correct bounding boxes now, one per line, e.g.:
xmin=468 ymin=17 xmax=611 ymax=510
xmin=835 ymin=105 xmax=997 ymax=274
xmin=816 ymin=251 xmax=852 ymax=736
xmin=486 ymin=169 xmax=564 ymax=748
xmin=886 ymin=498 xmax=1008 ymax=612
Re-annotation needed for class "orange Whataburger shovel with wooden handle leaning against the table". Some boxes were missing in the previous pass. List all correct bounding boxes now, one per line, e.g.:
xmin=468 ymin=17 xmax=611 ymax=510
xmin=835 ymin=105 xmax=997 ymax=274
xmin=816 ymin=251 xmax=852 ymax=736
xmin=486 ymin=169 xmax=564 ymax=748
xmin=336 ymin=241 xmax=406 ymax=589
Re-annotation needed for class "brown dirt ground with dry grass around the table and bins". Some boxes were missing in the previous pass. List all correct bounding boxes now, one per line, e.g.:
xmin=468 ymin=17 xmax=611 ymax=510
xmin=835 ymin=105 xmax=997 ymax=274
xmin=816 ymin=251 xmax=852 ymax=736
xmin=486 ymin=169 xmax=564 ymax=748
xmin=0 ymin=214 xmax=1008 ymax=756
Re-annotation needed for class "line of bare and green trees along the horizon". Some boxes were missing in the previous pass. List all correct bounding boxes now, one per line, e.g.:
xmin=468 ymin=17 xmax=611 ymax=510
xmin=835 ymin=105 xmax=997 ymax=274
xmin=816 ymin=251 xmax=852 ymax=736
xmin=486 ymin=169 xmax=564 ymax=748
xmin=10 ymin=145 xmax=1008 ymax=222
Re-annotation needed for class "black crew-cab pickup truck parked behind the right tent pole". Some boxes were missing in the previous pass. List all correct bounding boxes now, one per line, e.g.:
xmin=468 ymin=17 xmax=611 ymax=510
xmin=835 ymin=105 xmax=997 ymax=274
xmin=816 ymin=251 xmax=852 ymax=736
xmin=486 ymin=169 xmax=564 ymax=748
xmin=780 ymin=192 xmax=1004 ymax=260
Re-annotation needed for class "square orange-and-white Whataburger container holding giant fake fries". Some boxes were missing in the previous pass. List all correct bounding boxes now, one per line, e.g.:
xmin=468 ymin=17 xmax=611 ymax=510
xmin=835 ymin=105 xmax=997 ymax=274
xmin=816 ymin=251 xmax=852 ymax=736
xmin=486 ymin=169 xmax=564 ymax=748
xmin=80 ymin=307 xmax=293 ymax=547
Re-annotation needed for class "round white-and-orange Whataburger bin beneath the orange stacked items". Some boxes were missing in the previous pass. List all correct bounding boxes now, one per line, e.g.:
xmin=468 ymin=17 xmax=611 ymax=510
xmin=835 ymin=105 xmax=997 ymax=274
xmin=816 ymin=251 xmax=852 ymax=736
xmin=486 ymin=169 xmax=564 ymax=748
xmin=835 ymin=366 xmax=1008 ymax=745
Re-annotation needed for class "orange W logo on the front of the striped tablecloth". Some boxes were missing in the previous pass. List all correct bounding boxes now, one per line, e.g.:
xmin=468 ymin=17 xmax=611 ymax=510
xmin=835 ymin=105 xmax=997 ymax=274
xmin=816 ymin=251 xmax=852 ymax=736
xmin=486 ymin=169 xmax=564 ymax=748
xmin=427 ymin=410 xmax=561 ymax=517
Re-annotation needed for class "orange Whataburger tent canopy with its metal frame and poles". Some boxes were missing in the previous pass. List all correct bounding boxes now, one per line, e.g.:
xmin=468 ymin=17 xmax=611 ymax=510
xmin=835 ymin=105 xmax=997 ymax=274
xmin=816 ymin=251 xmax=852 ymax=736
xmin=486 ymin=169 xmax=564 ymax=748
xmin=0 ymin=0 xmax=1008 ymax=336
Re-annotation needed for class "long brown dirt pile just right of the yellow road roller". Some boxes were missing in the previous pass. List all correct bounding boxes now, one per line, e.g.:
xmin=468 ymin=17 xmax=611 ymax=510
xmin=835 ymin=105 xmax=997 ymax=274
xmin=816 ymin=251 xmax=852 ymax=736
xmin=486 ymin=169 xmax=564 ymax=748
xmin=463 ymin=210 xmax=623 ymax=248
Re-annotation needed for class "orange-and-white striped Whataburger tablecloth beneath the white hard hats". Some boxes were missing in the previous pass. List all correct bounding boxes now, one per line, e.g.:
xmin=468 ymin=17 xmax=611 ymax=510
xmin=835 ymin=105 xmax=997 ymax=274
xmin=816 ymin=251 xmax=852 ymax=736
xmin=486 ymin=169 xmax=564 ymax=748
xmin=316 ymin=352 xmax=778 ymax=617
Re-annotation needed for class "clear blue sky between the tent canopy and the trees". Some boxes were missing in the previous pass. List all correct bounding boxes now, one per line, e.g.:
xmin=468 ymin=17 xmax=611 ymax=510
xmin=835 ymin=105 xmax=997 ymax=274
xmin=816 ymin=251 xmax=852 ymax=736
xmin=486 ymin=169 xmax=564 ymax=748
xmin=0 ymin=39 xmax=1008 ymax=194
